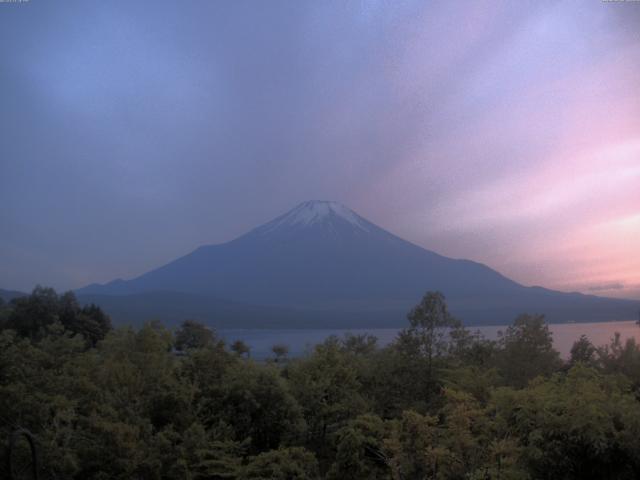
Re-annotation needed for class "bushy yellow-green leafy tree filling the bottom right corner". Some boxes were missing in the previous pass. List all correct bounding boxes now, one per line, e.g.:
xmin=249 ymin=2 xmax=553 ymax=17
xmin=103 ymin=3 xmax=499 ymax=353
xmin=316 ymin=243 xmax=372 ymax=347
xmin=491 ymin=364 xmax=640 ymax=480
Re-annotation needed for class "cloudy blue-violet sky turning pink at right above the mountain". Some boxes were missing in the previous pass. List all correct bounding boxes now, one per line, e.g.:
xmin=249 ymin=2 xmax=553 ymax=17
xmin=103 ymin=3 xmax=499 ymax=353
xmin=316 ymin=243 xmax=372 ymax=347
xmin=0 ymin=0 xmax=640 ymax=299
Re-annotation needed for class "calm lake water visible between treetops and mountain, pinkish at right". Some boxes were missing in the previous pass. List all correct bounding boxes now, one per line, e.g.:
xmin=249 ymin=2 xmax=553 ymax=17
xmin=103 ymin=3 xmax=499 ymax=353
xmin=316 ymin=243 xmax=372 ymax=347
xmin=218 ymin=320 xmax=640 ymax=359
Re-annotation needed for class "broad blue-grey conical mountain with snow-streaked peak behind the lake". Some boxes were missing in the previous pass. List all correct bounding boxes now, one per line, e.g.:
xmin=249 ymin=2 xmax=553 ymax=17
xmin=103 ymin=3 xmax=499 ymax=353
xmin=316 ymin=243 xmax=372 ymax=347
xmin=77 ymin=201 xmax=637 ymax=327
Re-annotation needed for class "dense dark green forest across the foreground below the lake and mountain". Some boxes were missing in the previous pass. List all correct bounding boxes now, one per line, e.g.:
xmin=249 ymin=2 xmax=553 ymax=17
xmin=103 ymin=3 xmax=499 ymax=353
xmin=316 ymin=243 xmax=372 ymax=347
xmin=0 ymin=287 xmax=640 ymax=480
